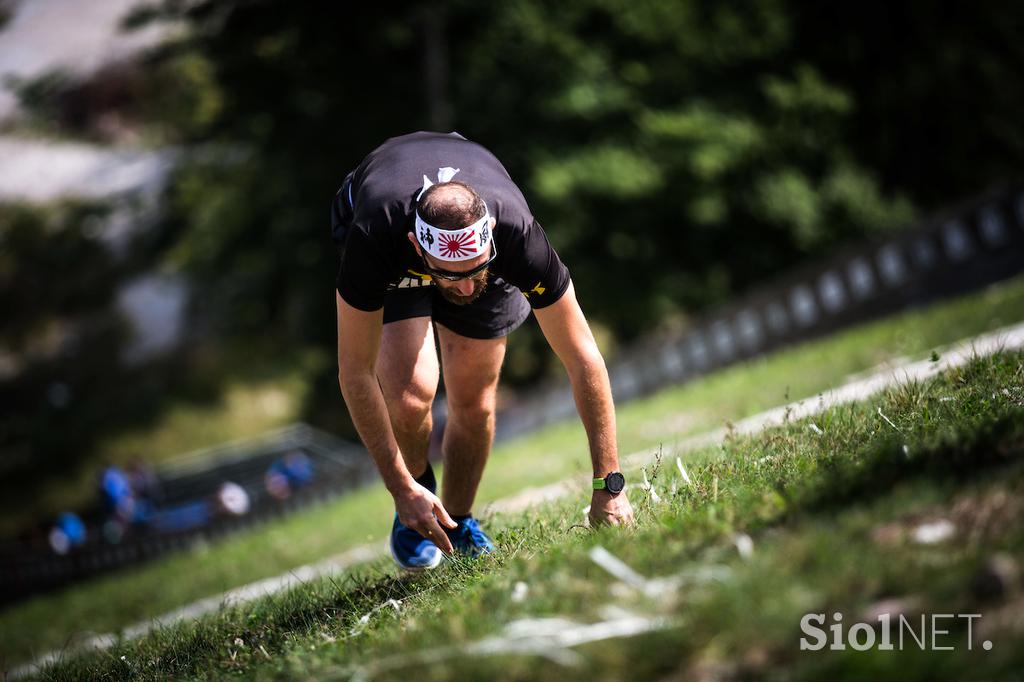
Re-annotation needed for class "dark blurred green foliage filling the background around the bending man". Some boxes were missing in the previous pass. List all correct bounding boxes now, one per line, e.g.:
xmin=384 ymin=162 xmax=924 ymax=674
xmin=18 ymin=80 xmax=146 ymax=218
xmin=132 ymin=0 xmax=1024 ymax=358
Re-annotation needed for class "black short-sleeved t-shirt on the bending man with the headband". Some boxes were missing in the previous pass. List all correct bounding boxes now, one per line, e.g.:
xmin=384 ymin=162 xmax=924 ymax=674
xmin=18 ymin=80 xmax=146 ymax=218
xmin=331 ymin=132 xmax=569 ymax=311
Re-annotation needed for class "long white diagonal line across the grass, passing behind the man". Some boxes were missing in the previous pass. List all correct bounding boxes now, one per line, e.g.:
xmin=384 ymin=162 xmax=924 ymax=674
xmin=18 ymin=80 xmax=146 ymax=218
xmin=14 ymin=317 xmax=1024 ymax=680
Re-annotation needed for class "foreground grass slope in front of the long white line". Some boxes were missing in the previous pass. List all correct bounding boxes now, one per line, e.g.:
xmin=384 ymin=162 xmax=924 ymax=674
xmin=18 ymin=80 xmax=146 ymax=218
xmin=28 ymin=352 xmax=1024 ymax=681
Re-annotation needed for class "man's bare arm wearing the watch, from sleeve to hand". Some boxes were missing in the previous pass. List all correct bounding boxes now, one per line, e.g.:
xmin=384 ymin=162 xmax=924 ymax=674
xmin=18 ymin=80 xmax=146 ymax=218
xmin=534 ymin=282 xmax=633 ymax=524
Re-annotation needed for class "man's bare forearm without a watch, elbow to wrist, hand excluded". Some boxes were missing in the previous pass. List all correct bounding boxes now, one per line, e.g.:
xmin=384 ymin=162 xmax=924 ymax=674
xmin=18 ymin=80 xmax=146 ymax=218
xmin=338 ymin=370 xmax=413 ymax=494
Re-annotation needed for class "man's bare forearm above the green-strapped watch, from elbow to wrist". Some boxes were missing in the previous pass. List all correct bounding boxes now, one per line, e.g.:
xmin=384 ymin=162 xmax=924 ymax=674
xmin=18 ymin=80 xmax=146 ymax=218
xmin=567 ymin=355 xmax=618 ymax=476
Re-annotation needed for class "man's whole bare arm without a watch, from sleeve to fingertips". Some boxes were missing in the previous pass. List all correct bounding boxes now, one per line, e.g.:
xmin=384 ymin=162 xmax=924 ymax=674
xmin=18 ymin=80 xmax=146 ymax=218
xmin=335 ymin=292 xmax=457 ymax=553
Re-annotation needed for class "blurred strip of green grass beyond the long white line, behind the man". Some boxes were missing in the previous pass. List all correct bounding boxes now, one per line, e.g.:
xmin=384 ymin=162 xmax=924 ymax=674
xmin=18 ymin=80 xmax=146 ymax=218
xmin=6 ymin=279 xmax=1024 ymax=662
